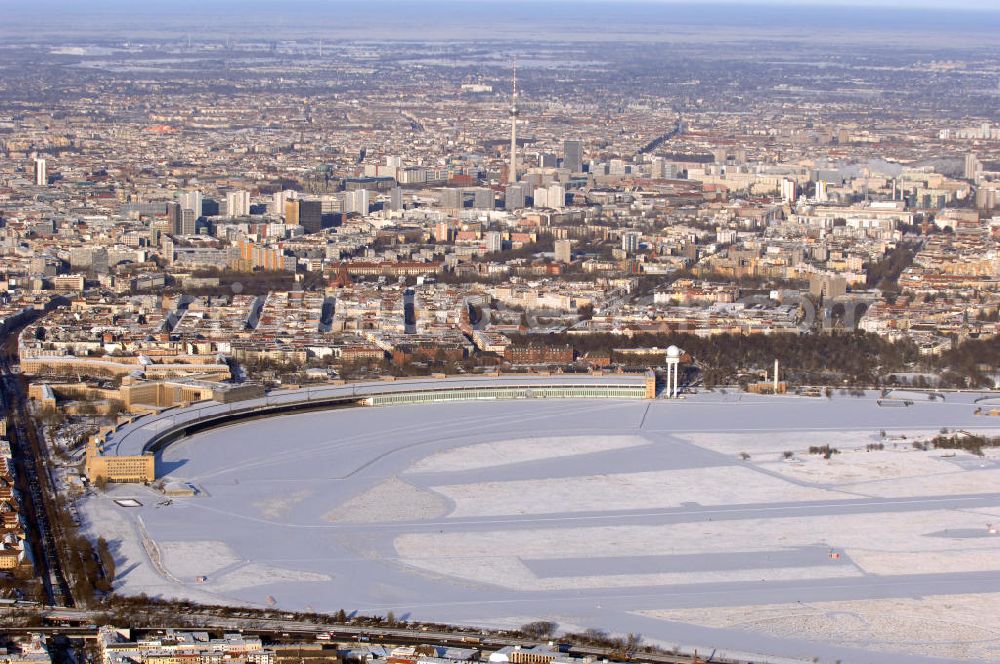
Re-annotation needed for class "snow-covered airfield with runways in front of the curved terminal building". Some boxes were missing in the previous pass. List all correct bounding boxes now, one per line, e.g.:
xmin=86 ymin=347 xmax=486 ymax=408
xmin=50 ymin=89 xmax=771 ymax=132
xmin=83 ymin=392 xmax=1000 ymax=662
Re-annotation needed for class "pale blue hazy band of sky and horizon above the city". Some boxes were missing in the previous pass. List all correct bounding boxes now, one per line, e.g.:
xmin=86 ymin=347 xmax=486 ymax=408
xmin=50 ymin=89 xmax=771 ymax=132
xmin=0 ymin=0 xmax=1000 ymax=44
